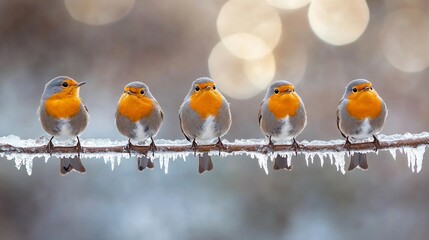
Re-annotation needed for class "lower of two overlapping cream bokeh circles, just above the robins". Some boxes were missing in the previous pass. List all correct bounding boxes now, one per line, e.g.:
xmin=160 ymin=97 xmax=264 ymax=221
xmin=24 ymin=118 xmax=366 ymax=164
xmin=208 ymin=42 xmax=276 ymax=99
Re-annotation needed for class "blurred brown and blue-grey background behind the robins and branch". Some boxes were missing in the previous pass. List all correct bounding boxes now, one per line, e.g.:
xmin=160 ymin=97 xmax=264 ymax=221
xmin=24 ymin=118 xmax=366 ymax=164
xmin=0 ymin=0 xmax=429 ymax=240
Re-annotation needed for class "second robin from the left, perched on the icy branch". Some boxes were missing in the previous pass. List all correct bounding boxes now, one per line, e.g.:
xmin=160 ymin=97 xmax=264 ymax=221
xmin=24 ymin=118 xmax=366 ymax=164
xmin=115 ymin=82 xmax=164 ymax=171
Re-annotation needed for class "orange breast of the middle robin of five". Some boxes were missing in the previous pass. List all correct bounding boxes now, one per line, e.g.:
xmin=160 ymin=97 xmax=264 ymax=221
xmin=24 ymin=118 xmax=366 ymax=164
xmin=190 ymin=90 xmax=222 ymax=119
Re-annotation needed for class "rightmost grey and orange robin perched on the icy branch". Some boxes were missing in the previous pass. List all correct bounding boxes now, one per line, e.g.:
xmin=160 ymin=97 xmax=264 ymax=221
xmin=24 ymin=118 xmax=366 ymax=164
xmin=337 ymin=79 xmax=387 ymax=171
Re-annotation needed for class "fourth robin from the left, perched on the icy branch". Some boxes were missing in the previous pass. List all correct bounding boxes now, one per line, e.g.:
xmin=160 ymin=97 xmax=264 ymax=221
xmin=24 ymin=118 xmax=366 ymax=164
xmin=258 ymin=80 xmax=307 ymax=170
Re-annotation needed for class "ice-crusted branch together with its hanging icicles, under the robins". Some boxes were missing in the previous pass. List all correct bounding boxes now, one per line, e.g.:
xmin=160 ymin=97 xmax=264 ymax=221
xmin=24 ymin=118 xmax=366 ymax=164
xmin=0 ymin=132 xmax=429 ymax=175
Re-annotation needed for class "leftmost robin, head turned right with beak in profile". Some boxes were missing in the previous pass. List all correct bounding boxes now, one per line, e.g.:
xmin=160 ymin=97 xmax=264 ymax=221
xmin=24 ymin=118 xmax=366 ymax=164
xmin=38 ymin=76 xmax=89 ymax=175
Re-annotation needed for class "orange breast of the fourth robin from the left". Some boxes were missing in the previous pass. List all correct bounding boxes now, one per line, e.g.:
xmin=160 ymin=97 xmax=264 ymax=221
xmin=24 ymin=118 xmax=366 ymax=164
xmin=268 ymin=93 xmax=300 ymax=119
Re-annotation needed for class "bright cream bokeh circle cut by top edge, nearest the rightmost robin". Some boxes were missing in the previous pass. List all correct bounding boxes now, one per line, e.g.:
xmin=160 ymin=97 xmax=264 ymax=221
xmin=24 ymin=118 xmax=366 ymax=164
xmin=308 ymin=0 xmax=369 ymax=45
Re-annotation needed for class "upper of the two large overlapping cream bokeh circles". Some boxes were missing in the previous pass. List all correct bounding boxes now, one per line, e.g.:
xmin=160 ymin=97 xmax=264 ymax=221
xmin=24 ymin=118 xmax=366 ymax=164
xmin=217 ymin=0 xmax=282 ymax=59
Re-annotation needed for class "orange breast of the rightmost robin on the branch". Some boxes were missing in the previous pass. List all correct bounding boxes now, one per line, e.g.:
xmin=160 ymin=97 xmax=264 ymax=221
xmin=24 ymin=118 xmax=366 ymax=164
xmin=346 ymin=91 xmax=382 ymax=120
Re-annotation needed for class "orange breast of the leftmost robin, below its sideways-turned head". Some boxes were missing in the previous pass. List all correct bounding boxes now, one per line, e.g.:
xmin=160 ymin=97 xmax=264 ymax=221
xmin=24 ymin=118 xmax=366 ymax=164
xmin=45 ymin=95 xmax=81 ymax=119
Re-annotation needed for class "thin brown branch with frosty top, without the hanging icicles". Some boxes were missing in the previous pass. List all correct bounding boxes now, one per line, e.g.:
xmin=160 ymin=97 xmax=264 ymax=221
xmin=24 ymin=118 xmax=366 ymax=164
xmin=0 ymin=134 xmax=429 ymax=155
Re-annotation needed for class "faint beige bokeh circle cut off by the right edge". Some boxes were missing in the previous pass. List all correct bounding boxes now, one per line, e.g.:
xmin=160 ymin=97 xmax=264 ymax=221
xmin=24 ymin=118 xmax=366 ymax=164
xmin=380 ymin=8 xmax=429 ymax=72
